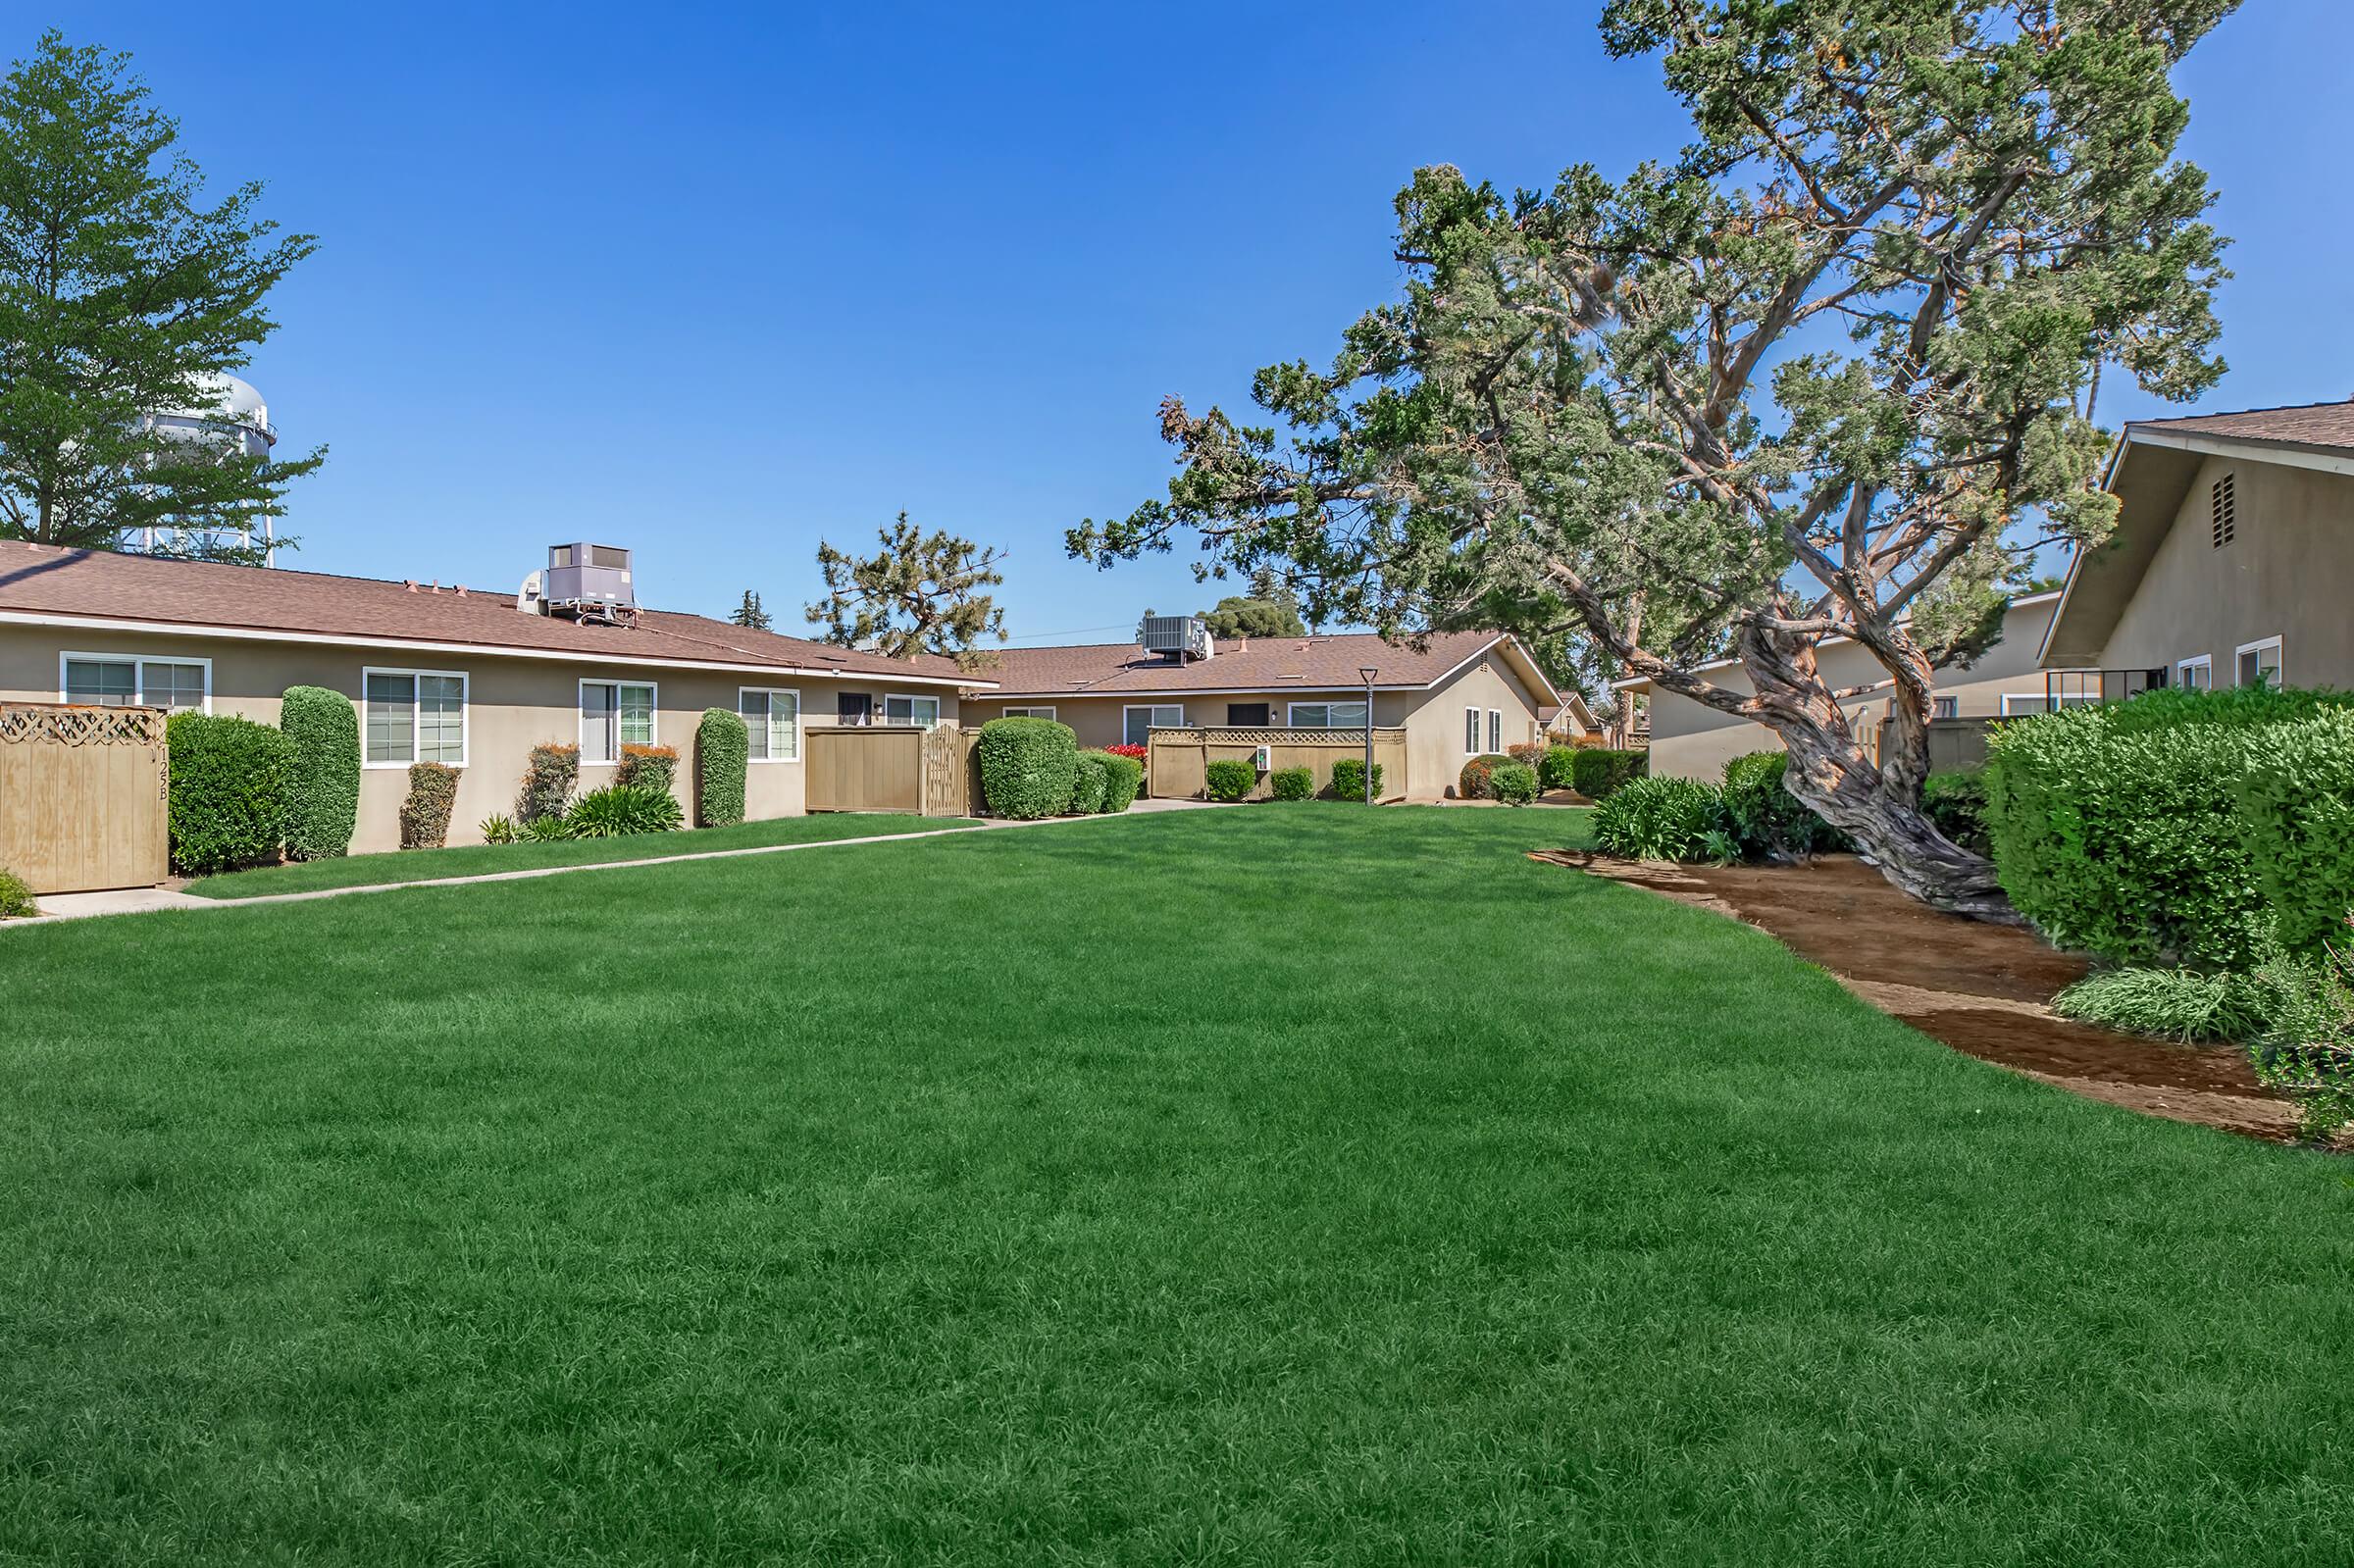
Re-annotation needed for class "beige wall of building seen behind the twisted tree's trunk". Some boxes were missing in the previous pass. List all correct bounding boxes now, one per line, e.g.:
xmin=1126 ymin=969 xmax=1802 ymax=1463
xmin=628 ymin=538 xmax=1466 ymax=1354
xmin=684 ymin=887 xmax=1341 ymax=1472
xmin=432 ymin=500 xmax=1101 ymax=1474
xmin=1650 ymin=598 xmax=2060 ymax=780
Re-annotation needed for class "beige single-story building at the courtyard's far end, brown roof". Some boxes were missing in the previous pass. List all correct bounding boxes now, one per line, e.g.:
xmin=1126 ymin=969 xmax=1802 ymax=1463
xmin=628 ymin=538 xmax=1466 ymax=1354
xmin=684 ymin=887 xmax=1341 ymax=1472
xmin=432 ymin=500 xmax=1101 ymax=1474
xmin=963 ymin=631 xmax=1582 ymax=800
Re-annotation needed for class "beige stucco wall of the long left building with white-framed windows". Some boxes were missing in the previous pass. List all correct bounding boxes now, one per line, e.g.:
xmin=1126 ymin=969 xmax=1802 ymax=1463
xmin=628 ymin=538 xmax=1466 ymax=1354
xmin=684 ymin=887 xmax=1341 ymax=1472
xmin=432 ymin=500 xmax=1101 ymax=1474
xmin=0 ymin=627 xmax=958 ymax=855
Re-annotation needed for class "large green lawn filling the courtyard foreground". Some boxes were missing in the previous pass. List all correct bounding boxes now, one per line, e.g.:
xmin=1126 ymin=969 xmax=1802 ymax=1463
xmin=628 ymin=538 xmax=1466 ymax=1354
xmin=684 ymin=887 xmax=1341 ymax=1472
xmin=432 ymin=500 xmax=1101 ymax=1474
xmin=0 ymin=805 xmax=2354 ymax=1568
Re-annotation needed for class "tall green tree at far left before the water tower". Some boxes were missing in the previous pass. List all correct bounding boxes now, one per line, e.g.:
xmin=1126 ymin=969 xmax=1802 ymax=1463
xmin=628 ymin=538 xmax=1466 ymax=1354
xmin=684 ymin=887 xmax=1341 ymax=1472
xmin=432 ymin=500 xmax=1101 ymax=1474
xmin=0 ymin=30 xmax=325 ymax=558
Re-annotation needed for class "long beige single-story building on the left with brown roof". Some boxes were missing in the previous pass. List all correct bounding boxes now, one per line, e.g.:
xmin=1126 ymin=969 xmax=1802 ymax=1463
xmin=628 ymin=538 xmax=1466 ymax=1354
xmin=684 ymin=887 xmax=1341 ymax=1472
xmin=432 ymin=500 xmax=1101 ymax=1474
xmin=0 ymin=541 xmax=991 ymax=855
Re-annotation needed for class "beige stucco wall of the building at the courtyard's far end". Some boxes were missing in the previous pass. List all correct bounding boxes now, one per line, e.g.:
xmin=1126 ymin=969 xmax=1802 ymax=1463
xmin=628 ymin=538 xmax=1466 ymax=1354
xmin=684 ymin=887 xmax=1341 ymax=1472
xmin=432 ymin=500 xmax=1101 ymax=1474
xmin=963 ymin=652 xmax=1540 ymax=800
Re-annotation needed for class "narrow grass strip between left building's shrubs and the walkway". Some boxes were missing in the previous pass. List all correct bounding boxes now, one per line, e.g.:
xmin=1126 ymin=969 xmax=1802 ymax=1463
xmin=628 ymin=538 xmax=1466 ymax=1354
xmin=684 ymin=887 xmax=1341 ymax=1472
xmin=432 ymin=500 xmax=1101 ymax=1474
xmin=188 ymin=812 xmax=979 ymax=899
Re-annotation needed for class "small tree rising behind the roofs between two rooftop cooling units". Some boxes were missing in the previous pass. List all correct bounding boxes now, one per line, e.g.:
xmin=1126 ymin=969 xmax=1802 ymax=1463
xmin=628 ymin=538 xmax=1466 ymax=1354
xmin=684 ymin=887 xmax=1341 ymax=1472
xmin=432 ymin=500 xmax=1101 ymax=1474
xmin=807 ymin=511 xmax=1005 ymax=664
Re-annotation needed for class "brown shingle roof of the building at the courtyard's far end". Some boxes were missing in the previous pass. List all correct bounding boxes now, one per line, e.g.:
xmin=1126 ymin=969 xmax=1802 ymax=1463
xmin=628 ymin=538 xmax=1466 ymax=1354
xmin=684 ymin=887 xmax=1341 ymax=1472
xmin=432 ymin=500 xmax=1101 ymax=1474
xmin=965 ymin=631 xmax=1561 ymax=701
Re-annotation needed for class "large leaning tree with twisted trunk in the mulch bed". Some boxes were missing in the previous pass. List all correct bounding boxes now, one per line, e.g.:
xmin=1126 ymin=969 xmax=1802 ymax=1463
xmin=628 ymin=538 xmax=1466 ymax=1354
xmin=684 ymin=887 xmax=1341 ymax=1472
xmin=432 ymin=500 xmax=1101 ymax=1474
xmin=1069 ymin=0 xmax=2231 ymax=918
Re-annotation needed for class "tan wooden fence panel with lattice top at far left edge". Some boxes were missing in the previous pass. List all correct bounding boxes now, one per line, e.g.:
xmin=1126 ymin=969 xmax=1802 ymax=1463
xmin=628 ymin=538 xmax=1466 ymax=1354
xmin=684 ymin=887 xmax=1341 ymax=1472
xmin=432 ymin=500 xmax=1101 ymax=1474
xmin=0 ymin=701 xmax=172 ymax=892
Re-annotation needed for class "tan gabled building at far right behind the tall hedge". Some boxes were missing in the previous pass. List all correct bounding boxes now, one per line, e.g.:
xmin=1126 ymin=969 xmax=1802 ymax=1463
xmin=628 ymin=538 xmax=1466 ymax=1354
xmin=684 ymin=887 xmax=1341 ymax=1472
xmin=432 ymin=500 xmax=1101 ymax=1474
xmin=2041 ymin=403 xmax=2354 ymax=699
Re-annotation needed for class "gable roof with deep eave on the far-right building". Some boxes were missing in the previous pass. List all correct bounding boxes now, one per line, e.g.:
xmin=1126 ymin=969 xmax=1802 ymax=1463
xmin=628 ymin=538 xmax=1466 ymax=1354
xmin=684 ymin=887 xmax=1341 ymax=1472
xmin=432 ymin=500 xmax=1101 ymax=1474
xmin=2038 ymin=400 xmax=2354 ymax=669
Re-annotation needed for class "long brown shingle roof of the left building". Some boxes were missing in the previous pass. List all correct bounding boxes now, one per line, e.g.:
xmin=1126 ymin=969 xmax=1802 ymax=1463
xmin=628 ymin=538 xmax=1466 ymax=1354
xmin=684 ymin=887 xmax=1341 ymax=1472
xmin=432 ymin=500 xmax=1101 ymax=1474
xmin=0 ymin=541 xmax=994 ymax=687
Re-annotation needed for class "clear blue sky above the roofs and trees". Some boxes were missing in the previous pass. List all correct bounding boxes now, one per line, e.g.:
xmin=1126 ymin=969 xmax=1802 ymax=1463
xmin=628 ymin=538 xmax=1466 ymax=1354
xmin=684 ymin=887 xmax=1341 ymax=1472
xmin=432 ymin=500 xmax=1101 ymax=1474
xmin=36 ymin=0 xmax=2354 ymax=640
